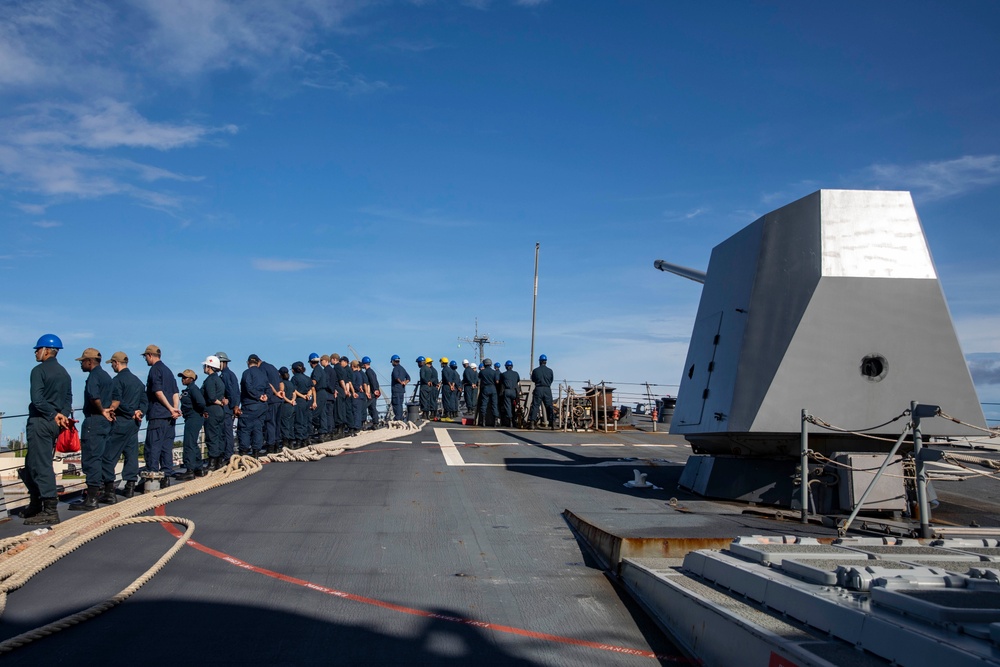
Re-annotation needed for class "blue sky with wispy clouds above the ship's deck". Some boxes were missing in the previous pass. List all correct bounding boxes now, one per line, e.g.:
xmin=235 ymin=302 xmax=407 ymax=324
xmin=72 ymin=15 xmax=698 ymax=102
xmin=0 ymin=0 xmax=1000 ymax=428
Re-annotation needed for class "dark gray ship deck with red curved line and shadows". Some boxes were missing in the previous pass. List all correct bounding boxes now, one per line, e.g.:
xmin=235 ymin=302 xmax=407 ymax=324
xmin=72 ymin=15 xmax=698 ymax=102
xmin=0 ymin=424 xmax=689 ymax=665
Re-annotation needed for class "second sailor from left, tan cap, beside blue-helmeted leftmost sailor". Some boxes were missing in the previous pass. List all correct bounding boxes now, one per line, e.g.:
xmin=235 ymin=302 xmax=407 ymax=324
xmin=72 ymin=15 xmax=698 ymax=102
xmin=69 ymin=347 xmax=112 ymax=511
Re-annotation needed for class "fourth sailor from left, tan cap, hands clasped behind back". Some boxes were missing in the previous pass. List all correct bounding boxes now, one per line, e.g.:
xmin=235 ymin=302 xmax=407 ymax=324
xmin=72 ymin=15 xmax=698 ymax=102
xmin=142 ymin=345 xmax=181 ymax=488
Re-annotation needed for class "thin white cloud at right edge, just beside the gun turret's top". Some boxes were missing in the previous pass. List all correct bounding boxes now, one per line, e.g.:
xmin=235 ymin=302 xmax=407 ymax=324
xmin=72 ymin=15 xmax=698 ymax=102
xmin=862 ymin=155 xmax=1000 ymax=200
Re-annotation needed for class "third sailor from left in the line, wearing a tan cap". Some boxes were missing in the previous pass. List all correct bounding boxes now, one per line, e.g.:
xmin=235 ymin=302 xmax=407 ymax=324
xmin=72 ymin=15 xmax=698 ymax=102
xmin=99 ymin=351 xmax=149 ymax=498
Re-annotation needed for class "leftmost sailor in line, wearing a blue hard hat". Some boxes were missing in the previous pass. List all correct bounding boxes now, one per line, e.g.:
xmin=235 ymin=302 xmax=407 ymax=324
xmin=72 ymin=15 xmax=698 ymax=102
xmin=21 ymin=334 xmax=73 ymax=526
